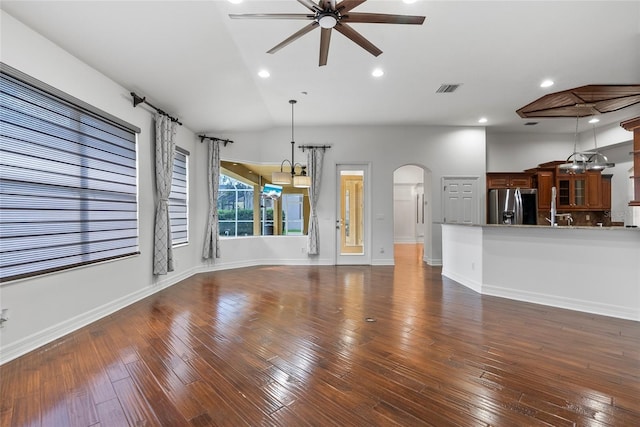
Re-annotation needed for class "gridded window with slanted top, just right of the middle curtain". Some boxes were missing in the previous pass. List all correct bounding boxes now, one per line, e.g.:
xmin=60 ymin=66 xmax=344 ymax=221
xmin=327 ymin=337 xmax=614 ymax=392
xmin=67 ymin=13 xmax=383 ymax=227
xmin=218 ymin=173 xmax=253 ymax=236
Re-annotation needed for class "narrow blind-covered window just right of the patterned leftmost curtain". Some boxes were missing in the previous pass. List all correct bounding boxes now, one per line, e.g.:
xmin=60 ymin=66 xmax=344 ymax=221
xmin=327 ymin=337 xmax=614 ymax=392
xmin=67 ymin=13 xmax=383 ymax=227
xmin=169 ymin=147 xmax=189 ymax=246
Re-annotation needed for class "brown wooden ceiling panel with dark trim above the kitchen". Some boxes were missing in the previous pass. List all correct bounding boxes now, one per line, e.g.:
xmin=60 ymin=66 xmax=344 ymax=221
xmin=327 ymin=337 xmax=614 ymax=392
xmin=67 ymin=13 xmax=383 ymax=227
xmin=516 ymin=84 xmax=640 ymax=118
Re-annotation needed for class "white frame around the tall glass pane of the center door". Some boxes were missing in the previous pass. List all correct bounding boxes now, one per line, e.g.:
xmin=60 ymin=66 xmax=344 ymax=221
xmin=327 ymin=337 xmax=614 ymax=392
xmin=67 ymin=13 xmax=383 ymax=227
xmin=333 ymin=162 xmax=373 ymax=265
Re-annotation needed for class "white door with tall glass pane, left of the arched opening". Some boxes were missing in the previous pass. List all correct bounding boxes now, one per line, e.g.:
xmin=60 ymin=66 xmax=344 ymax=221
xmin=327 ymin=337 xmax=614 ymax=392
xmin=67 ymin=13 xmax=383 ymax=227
xmin=336 ymin=164 xmax=371 ymax=265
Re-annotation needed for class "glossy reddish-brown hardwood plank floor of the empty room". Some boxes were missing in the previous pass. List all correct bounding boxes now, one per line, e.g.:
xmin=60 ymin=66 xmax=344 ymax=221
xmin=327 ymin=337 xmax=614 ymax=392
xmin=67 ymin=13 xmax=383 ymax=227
xmin=0 ymin=245 xmax=640 ymax=427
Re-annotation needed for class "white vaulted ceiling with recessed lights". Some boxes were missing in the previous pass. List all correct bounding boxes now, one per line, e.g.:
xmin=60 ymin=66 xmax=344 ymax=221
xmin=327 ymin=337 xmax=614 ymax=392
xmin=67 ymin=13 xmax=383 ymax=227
xmin=0 ymin=0 xmax=640 ymax=133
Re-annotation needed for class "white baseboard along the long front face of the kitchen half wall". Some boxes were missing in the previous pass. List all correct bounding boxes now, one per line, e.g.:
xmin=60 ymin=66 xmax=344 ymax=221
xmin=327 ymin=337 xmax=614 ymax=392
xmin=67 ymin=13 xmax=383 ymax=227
xmin=482 ymin=279 xmax=640 ymax=321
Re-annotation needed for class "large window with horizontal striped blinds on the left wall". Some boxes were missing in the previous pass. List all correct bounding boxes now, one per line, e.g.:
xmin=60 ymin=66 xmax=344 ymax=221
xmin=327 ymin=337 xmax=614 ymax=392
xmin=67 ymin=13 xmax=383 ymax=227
xmin=0 ymin=64 xmax=139 ymax=282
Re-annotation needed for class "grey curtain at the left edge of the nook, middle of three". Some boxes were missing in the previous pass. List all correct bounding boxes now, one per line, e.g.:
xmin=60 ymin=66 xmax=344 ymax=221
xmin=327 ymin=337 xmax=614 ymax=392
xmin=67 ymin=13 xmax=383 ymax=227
xmin=202 ymin=141 xmax=220 ymax=259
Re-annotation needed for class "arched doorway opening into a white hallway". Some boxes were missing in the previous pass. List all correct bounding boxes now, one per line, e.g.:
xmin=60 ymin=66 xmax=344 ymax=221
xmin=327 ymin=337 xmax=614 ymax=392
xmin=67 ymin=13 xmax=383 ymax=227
xmin=393 ymin=164 xmax=432 ymax=263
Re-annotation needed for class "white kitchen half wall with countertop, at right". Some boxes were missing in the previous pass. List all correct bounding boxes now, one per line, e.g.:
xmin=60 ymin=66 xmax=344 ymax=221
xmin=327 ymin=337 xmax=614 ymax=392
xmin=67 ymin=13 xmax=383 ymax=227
xmin=442 ymin=224 xmax=640 ymax=321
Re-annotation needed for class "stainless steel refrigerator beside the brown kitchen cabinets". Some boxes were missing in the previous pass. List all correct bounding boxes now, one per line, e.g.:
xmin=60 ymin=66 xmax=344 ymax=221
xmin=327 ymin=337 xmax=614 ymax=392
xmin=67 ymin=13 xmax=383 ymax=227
xmin=488 ymin=188 xmax=538 ymax=225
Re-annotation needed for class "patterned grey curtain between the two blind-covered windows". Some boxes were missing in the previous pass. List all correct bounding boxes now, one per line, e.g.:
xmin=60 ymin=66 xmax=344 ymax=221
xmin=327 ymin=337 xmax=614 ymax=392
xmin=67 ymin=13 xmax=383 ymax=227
xmin=153 ymin=114 xmax=176 ymax=274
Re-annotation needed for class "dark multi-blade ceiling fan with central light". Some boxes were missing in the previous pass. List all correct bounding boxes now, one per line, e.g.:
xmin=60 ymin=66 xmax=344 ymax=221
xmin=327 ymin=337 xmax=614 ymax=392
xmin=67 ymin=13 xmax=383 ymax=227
xmin=229 ymin=0 xmax=425 ymax=66
